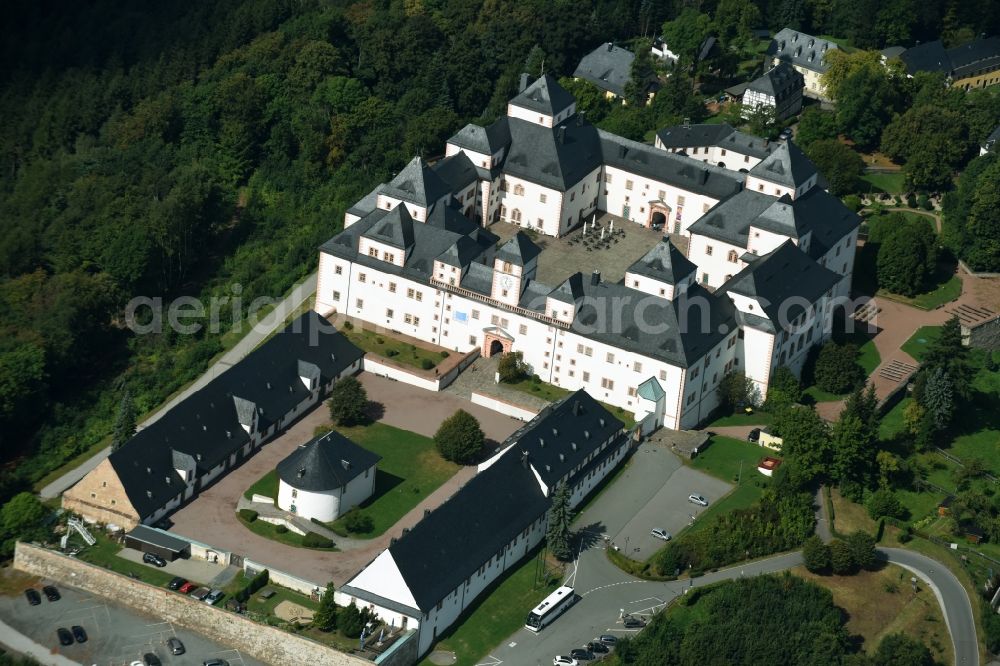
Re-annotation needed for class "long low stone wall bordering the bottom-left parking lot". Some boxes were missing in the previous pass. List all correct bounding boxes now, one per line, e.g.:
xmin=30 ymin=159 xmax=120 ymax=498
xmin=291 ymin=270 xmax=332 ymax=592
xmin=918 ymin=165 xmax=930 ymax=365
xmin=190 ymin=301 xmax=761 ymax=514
xmin=14 ymin=543 xmax=372 ymax=666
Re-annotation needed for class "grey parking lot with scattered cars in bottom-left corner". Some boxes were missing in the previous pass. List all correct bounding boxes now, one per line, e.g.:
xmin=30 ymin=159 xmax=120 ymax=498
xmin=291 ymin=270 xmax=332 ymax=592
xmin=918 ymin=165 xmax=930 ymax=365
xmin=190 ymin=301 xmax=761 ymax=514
xmin=0 ymin=583 xmax=265 ymax=666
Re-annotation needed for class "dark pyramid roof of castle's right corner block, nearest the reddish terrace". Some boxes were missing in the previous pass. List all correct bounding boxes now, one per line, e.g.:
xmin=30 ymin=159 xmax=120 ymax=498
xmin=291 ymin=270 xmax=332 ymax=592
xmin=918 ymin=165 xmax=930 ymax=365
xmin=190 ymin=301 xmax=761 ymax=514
xmin=718 ymin=240 xmax=841 ymax=328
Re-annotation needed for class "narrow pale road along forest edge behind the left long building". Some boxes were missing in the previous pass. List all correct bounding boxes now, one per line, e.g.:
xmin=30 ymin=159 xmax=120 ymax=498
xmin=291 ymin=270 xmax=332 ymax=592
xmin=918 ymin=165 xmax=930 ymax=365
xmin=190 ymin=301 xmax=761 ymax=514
xmin=39 ymin=273 xmax=316 ymax=499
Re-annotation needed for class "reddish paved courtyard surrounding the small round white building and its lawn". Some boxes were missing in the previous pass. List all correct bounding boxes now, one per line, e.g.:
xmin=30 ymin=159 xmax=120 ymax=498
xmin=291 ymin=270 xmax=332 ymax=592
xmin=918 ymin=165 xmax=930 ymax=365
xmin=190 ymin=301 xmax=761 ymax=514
xmin=171 ymin=373 xmax=522 ymax=585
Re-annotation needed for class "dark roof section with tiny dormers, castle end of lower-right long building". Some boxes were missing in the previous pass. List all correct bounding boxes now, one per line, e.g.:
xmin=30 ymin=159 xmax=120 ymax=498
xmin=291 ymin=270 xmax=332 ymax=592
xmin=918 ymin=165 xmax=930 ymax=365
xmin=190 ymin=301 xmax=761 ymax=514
xmin=506 ymin=389 xmax=625 ymax=488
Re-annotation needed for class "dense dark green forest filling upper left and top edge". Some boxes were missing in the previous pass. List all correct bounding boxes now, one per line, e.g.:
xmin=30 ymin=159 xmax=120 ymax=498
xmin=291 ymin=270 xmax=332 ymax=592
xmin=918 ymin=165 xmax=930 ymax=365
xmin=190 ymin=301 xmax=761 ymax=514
xmin=0 ymin=0 xmax=1000 ymax=499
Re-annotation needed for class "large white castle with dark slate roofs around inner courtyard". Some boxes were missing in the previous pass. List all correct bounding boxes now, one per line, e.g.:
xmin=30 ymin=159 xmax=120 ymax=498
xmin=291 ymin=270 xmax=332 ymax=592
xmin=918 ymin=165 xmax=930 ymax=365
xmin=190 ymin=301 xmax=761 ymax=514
xmin=315 ymin=75 xmax=859 ymax=428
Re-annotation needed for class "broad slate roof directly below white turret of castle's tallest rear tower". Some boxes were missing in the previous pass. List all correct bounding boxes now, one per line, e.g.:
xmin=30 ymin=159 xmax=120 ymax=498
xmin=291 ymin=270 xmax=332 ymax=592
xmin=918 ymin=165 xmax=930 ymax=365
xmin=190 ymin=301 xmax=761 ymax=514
xmin=503 ymin=117 xmax=601 ymax=192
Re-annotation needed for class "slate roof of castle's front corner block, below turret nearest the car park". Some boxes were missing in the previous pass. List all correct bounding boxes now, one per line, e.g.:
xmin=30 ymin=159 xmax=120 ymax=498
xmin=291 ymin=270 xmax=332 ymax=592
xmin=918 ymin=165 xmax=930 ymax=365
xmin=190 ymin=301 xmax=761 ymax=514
xmin=571 ymin=279 xmax=735 ymax=367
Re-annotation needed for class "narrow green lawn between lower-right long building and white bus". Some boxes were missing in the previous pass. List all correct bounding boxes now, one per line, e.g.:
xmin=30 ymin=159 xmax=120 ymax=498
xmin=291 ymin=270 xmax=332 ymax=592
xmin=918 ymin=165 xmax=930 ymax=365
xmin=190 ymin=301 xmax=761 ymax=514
xmin=419 ymin=552 xmax=556 ymax=666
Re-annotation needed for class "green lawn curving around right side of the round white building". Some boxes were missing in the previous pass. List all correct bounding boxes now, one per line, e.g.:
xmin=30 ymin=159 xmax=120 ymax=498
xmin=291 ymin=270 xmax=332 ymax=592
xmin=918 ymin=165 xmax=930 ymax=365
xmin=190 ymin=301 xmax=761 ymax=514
xmin=332 ymin=423 xmax=459 ymax=538
